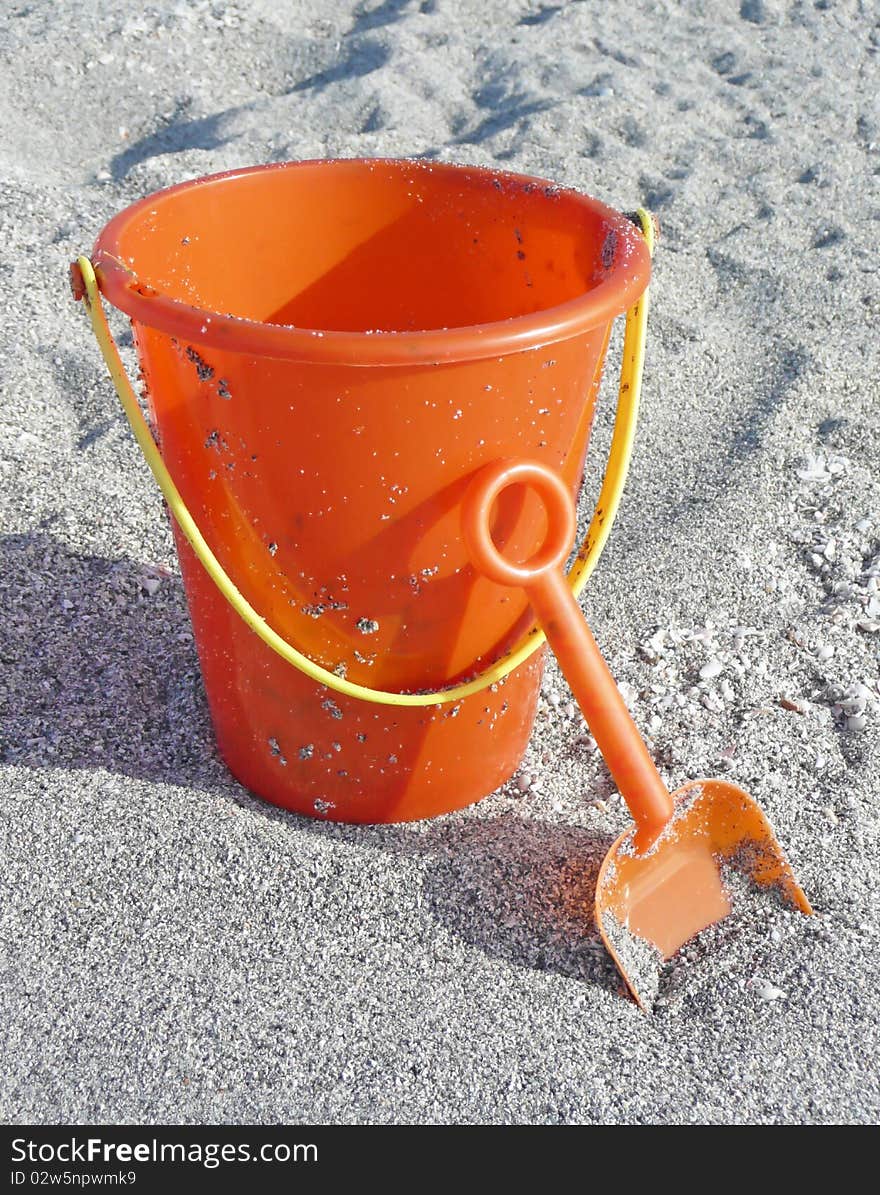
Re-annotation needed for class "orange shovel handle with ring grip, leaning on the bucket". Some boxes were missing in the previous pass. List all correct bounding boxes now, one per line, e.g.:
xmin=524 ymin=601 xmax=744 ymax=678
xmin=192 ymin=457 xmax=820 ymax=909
xmin=462 ymin=460 xmax=673 ymax=851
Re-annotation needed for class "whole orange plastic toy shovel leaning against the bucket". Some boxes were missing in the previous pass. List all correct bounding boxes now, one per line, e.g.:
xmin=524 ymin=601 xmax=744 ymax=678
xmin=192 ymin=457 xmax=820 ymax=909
xmin=463 ymin=460 xmax=812 ymax=1010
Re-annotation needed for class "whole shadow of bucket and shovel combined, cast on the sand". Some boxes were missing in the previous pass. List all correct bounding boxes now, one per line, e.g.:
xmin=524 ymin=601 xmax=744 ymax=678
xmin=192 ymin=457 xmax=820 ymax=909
xmin=0 ymin=532 xmax=618 ymax=991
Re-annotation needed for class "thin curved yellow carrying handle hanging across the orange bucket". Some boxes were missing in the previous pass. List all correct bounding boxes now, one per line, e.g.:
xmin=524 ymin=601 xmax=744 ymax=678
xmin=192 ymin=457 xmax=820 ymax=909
xmin=77 ymin=208 xmax=654 ymax=706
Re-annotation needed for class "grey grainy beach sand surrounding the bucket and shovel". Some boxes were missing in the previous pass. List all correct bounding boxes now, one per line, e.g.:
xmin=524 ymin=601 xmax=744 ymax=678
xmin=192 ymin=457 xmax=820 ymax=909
xmin=0 ymin=0 xmax=880 ymax=1124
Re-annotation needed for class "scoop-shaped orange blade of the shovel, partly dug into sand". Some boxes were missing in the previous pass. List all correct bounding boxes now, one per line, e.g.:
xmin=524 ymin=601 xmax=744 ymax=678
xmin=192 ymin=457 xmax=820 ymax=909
xmin=595 ymin=780 xmax=812 ymax=1011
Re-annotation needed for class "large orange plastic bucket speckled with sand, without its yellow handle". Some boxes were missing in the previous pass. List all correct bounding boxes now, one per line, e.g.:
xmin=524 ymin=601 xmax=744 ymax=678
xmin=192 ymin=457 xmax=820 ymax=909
xmin=78 ymin=160 xmax=650 ymax=822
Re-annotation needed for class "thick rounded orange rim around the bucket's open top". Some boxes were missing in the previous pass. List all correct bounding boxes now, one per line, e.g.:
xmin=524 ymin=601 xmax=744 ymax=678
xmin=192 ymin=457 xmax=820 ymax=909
xmin=92 ymin=157 xmax=650 ymax=366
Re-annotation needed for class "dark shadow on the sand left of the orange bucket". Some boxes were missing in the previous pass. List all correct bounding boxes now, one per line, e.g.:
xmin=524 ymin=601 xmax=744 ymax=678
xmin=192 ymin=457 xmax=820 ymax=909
xmin=0 ymin=533 xmax=226 ymax=789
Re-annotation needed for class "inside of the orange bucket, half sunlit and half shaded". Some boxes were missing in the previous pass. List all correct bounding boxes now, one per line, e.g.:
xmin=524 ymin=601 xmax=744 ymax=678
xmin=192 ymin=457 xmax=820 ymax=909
xmin=108 ymin=160 xmax=617 ymax=332
